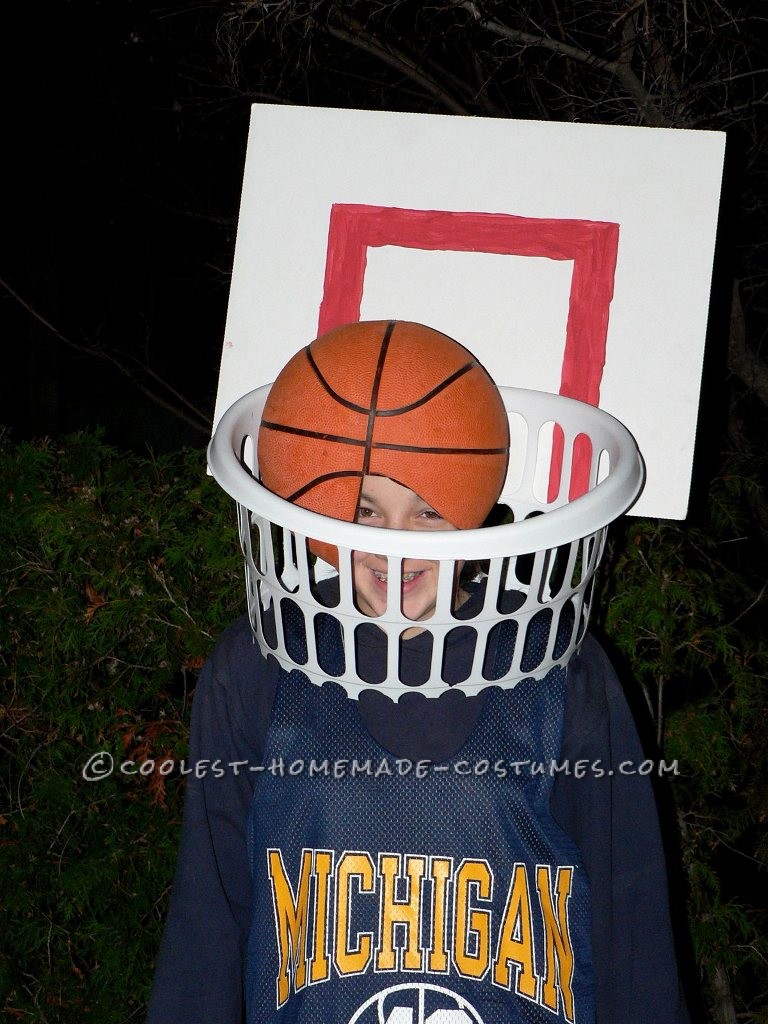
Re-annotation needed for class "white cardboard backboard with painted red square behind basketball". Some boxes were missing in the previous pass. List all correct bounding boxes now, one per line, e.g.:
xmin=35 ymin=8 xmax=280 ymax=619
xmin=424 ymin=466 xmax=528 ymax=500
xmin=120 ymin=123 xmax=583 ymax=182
xmin=215 ymin=105 xmax=725 ymax=519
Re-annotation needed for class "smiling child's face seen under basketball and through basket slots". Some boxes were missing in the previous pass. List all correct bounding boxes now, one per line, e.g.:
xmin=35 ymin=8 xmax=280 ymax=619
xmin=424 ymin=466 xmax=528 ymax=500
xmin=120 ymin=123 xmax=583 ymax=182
xmin=352 ymin=476 xmax=456 ymax=622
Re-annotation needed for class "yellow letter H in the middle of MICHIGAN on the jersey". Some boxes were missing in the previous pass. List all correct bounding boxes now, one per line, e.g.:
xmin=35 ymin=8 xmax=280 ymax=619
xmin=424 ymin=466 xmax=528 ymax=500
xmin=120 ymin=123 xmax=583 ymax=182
xmin=376 ymin=853 xmax=426 ymax=971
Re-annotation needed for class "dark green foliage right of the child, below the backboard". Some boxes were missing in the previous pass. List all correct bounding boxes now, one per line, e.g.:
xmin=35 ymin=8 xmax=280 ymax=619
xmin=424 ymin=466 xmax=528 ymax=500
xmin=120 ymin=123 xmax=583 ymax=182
xmin=599 ymin=454 xmax=768 ymax=1022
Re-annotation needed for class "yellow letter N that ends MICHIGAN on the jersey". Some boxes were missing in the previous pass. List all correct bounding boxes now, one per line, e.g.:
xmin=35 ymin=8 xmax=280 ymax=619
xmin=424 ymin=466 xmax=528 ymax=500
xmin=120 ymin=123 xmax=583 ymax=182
xmin=536 ymin=864 xmax=573 ymax=1022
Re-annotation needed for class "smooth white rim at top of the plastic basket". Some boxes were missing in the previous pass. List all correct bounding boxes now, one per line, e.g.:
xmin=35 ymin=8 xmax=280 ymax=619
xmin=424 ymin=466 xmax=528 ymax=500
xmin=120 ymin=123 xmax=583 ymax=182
xmin=208 ymin=384 xmax=645 ymax=561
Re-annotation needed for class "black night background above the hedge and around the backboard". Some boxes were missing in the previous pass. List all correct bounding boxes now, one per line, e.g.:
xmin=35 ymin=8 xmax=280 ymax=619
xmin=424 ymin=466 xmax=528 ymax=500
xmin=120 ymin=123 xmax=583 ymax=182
xmin=0 ymin=0 xmax=768 ymax=460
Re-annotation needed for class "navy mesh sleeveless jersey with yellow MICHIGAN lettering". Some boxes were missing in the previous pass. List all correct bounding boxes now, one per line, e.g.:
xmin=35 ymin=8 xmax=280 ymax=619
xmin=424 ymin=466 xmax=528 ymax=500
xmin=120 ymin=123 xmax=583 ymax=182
xmin=246 ymin=647 xmax=595 ymax=1024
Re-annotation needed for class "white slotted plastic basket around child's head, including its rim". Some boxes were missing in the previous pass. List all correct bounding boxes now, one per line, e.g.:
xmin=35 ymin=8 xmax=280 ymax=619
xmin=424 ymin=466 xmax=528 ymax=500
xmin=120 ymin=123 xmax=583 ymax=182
xmin=209 ymin=387 xmax=643 ymax=699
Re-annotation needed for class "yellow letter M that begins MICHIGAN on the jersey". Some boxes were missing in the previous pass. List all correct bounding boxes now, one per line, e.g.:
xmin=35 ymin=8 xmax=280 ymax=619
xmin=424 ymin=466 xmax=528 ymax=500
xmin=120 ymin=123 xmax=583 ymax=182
xmin=266 ymin=850 xmax=312 ymax=1007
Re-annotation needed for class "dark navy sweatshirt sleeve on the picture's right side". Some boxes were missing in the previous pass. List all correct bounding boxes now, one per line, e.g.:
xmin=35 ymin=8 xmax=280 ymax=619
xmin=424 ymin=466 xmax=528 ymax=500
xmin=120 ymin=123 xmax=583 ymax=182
xmin=552 ymin=637 xmax=688 ymax=1024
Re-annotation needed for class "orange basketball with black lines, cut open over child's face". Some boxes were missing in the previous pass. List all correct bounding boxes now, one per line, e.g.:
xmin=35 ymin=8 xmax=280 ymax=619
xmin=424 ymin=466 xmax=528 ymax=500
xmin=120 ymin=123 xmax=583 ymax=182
xmin=258 ymin=321 xmax=509 ymax=544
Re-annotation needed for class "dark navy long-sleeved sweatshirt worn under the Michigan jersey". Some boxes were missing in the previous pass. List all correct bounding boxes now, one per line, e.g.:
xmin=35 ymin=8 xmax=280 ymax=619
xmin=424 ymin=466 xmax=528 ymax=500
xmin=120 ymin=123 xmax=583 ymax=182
xmin=148 ymin=617 xmax=688 ymax=1024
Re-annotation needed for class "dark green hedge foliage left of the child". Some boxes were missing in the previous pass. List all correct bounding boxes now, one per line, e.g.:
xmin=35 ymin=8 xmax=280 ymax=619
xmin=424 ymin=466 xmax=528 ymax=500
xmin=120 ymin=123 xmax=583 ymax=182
xmin=0 ymin=434 xmax=244 ymax=1024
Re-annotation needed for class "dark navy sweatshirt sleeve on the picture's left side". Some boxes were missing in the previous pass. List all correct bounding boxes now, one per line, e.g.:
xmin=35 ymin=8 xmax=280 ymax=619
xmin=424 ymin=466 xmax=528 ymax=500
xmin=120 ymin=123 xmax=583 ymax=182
xmin=147 ymin=620 xmax=276 ymax=1024
